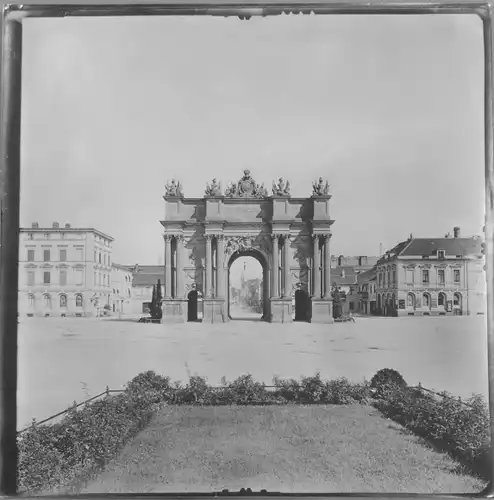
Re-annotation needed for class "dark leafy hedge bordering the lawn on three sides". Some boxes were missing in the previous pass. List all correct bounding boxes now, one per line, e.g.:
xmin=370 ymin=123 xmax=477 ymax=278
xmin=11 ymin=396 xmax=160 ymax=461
xmin=18 ymin=369 xmax=490 ymax=494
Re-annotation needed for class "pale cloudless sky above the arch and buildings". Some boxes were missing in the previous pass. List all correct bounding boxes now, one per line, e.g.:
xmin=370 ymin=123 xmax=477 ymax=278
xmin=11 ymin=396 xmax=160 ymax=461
xmin=21 ymin=15 xmax=484 ymax=265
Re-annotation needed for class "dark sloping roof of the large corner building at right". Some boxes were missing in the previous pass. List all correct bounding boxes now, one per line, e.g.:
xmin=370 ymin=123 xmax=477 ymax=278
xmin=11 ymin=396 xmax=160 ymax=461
xmin=392 ymin=237 xmax=482 ymax=256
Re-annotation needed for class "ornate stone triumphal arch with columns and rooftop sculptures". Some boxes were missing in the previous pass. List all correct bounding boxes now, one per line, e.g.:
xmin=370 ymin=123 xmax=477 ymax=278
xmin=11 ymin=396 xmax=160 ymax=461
xmin=161 ymin=170 xmax=334 ymax=323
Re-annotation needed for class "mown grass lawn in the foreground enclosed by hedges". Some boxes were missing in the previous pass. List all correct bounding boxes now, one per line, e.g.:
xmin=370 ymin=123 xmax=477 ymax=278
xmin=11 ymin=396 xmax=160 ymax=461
xmin=81 ymin=405 xmax=485 ymax=493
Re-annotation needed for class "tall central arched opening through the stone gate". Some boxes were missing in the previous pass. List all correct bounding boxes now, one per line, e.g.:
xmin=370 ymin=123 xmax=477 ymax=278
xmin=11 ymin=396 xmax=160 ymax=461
xmin=227 ymin=249 xmax=269 ymax=321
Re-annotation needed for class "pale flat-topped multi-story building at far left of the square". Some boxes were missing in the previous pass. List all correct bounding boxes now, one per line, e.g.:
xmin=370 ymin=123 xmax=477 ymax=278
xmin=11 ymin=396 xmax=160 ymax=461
xmin=18 ymin=222 xmax=113 ymax=316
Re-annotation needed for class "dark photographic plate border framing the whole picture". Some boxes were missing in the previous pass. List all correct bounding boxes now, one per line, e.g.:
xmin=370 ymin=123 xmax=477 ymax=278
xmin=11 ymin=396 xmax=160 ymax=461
xmin=0 ymin=0 xmax=494 ymax=498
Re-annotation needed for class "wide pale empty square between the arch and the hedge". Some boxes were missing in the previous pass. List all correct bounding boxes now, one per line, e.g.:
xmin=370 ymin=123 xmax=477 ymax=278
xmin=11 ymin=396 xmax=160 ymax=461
xmin=18 ymin=316 xmax=488 ymax=428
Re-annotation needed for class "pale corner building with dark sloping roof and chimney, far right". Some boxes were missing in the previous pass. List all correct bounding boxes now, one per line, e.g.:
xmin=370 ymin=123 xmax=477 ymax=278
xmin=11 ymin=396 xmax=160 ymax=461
xmin=376 ymin=227 xmax=486 ymax=316
